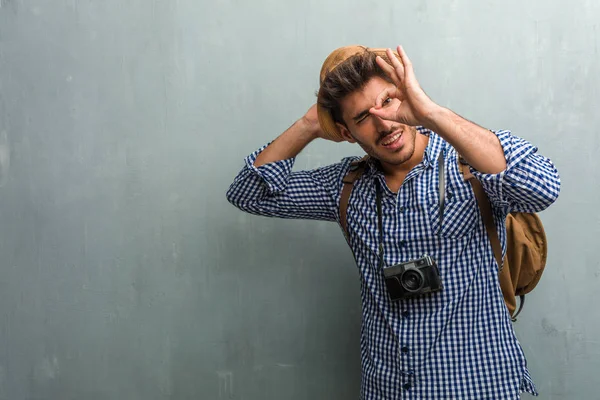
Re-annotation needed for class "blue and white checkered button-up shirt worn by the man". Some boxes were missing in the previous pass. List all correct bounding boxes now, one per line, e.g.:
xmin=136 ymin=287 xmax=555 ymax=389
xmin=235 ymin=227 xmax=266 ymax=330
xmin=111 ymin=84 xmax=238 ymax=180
xmin=227 ymin=128 xmax=560 ymax=400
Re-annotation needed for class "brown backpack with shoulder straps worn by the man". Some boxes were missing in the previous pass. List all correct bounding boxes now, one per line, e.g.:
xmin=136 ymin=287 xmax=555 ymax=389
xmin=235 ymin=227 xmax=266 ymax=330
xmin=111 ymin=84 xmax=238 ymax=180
xmin=340 ymin=156 xmax=548 ymax=321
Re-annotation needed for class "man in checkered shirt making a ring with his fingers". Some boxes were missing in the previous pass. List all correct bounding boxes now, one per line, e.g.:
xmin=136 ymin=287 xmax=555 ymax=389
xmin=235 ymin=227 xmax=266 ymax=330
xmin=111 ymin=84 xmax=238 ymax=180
xmin=227 ymin=46 xmax=560 ymax=400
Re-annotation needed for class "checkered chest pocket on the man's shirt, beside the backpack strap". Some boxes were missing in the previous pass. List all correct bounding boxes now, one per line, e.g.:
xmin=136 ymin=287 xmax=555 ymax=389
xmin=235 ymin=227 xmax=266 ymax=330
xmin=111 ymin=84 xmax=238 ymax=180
xmin=428 ymin=190 xmax=479 ymax=239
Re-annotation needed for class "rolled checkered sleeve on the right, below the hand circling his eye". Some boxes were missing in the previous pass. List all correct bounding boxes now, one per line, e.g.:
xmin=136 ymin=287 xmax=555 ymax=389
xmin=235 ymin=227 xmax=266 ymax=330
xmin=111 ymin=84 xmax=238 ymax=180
xmin=470 ymin=130 xmax=560 ymax=212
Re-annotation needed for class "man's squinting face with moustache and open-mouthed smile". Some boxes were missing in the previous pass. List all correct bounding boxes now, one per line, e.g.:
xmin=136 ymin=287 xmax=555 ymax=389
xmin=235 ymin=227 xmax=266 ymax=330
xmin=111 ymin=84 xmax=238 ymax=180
xmin=338 ymin=77 xmax=417 ymax=166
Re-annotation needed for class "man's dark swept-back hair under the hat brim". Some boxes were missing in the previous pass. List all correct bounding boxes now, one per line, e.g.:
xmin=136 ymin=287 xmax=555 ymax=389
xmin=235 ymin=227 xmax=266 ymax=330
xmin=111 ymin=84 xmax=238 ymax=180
xmin=317 ymin=49 xmax=392 ymax=126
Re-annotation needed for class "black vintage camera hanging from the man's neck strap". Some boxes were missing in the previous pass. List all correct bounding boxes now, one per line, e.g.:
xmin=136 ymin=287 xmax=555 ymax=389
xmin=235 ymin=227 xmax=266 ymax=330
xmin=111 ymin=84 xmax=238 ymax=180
xmin=383 ymin=255 xmax=443 ymax=301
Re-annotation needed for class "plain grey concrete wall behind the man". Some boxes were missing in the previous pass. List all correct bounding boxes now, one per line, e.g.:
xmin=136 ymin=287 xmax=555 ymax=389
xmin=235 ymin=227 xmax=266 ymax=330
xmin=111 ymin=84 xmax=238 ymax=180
xmin=0 ymin=0 xmax=600 ymax=400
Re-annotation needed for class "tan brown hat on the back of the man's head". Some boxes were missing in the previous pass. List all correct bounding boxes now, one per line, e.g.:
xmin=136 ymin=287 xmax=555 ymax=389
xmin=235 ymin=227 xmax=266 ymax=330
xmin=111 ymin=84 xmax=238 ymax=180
xmin=317 ymin=45 xmax=400 ymax=142
